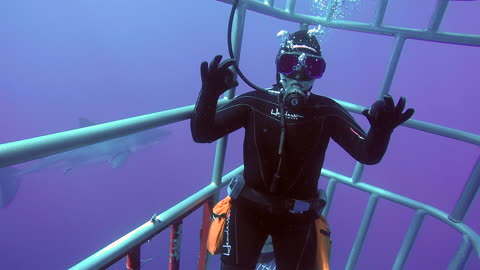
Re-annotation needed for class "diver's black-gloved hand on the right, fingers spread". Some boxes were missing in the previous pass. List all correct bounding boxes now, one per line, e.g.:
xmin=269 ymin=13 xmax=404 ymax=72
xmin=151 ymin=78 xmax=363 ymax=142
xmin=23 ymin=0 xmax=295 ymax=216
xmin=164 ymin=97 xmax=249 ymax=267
xmin=362 ymin=95 xmax=415 ymax=130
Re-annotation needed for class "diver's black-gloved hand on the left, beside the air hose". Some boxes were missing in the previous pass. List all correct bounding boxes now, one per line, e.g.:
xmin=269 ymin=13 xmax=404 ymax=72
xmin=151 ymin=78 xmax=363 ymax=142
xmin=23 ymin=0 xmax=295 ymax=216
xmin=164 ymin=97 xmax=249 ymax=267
xmin=200 ymin=55 xmax=238 ymax=97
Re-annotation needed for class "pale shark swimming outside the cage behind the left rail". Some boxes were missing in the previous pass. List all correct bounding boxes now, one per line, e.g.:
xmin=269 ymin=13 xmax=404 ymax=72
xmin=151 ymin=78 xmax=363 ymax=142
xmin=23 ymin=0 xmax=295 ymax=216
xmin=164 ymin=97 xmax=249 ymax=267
xmin=0 ymin=118 xmax=171 ymax=208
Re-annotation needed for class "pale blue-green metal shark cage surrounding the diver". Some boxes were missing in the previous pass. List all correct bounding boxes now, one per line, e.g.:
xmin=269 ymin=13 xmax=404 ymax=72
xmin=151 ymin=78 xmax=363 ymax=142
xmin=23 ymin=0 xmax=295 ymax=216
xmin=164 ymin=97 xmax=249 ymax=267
xmin=0 ymin=0 xmax=480 ymax=270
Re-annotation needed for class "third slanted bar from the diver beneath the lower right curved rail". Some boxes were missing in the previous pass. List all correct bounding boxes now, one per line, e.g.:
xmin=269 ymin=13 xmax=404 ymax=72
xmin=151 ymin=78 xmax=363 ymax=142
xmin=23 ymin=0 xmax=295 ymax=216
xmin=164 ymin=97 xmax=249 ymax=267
xmin=392 ymin=210 xmax=425 ymax=270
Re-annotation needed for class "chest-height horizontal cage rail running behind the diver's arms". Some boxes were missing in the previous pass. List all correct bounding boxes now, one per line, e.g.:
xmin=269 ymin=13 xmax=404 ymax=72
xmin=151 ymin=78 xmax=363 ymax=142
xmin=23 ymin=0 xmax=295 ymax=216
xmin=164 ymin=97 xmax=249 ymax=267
xmin=0 ymin=99 xmax=480 ymax=171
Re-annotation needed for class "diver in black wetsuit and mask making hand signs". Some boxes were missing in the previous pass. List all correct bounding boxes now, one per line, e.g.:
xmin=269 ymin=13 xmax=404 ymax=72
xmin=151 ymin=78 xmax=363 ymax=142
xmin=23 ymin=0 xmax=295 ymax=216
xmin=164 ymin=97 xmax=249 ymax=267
xmin=190 ymin=30 xmax=414 ymax=270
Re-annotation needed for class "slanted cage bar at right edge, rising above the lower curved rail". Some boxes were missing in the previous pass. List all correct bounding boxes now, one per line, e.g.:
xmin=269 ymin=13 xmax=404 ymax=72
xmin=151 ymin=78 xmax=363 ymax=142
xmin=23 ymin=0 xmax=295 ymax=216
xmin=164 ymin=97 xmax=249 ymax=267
xmin=448 ymin=156 xmax=480 ymax=222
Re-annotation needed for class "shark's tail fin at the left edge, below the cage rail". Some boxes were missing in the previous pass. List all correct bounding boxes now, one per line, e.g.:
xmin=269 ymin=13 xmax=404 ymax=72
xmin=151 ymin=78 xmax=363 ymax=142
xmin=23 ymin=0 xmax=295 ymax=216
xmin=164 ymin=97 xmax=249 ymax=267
xmin=0 ymin=167 xmax=20 ymax=208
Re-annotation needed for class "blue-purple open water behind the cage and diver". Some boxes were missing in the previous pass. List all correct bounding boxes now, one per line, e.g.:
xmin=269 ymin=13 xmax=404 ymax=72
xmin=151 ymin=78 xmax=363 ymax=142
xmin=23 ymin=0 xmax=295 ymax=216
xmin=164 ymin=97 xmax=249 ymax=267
xmin=0 ymin=0 xmax=480 ymax=270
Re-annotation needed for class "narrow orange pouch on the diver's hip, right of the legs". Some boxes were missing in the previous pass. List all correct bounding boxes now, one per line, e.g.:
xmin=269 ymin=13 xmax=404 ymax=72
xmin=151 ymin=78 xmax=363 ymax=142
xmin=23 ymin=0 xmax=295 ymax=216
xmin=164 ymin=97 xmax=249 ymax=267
xmin=315 ymin=216 xmax=332 ymax=270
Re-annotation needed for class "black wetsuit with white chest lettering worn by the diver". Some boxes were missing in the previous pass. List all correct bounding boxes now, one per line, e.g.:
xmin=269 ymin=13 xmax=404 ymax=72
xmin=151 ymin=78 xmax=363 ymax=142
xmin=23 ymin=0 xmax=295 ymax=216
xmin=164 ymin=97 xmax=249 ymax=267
xmin=191 ymin=88 xmax=391 ymax=269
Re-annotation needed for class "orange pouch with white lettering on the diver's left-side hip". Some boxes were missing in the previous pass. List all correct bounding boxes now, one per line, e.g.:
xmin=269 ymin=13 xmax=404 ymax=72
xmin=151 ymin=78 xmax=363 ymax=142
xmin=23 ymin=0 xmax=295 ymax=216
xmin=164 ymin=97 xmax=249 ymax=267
xmin=207 ymin=196 xmax=231 ymax=255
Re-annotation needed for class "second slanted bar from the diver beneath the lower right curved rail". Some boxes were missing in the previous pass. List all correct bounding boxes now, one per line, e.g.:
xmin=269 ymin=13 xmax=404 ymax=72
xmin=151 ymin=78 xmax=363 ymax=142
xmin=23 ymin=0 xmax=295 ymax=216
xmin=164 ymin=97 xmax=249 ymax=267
xmin=345 ymin=194 xmax=378 ymax=270
